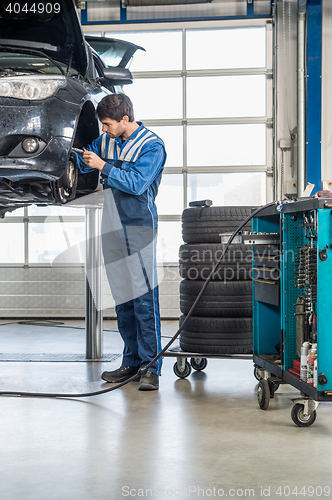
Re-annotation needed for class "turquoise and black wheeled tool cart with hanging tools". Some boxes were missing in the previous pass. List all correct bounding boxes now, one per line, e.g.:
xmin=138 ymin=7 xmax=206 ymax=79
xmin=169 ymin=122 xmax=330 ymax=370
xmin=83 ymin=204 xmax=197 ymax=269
xmin=252 ymin=198 xmax=332 ymax=427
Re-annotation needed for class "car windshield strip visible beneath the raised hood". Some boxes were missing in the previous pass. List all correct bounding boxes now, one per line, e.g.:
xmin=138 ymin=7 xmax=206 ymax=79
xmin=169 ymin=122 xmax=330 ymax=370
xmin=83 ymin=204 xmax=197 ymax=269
xmin=0 ymin=51 xmax=77 ymax=76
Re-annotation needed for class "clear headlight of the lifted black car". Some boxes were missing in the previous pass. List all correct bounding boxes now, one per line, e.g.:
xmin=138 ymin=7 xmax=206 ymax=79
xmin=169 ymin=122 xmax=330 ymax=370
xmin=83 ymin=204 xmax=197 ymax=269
xmin=0 ymin=75 xmax=67 ymax=101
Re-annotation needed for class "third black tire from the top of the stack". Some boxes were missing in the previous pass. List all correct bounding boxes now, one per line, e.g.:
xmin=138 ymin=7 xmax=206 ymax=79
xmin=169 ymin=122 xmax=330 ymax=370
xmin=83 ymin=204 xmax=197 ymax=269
xmin=180 ymin=280 xmax=252 ymax=318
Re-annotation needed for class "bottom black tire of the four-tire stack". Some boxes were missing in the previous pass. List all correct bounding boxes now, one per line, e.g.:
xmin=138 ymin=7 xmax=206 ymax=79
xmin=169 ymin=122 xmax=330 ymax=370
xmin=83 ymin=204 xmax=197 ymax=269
xmin=179 ymin=315 xmax=252 ymax=354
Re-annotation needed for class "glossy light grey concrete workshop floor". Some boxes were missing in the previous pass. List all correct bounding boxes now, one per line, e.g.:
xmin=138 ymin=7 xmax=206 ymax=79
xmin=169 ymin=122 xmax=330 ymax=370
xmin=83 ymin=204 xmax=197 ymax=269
xmin=0 ymin=321 xmax=332 ymax=500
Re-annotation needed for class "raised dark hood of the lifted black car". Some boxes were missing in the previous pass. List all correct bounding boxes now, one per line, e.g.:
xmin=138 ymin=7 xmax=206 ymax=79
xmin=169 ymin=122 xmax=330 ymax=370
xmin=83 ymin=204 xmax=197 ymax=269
xmin=0 ymin=0 xmax=88 ymax=75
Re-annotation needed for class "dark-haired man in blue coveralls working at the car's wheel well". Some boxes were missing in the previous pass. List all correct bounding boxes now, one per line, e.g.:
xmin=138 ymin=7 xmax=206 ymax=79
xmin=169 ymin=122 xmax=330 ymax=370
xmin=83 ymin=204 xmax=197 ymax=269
xmin=78 ymin=94 xmax=166 ymax=391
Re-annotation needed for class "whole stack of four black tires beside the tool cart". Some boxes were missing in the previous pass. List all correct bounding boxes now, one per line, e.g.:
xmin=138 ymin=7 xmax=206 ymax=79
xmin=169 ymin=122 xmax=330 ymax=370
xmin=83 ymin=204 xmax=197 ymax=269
xmin=179 ymin=206 xmax=252 ymax=355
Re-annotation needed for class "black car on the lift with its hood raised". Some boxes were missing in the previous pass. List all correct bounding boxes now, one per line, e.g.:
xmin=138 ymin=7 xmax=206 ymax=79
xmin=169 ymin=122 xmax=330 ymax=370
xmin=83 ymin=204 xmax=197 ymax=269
xmin=0 ymin=0 xmax=144 ymax=214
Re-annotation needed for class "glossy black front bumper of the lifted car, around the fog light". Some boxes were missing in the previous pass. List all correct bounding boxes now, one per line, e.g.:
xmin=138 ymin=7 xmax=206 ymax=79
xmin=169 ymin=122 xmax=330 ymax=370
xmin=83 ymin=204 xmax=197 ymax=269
xmin=0 ymin=97 xmax=79 ymax=182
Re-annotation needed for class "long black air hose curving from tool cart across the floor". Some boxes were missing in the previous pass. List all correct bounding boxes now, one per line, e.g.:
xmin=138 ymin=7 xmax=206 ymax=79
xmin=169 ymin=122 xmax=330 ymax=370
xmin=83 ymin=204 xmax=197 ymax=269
xmin=0 ymin=201 xmax=279 ymax=398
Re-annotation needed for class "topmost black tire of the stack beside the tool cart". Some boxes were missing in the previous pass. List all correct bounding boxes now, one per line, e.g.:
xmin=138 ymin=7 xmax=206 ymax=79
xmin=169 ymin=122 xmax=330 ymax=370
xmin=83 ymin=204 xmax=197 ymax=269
xmin=182 ymin=207 xmax=252 ymax=243
